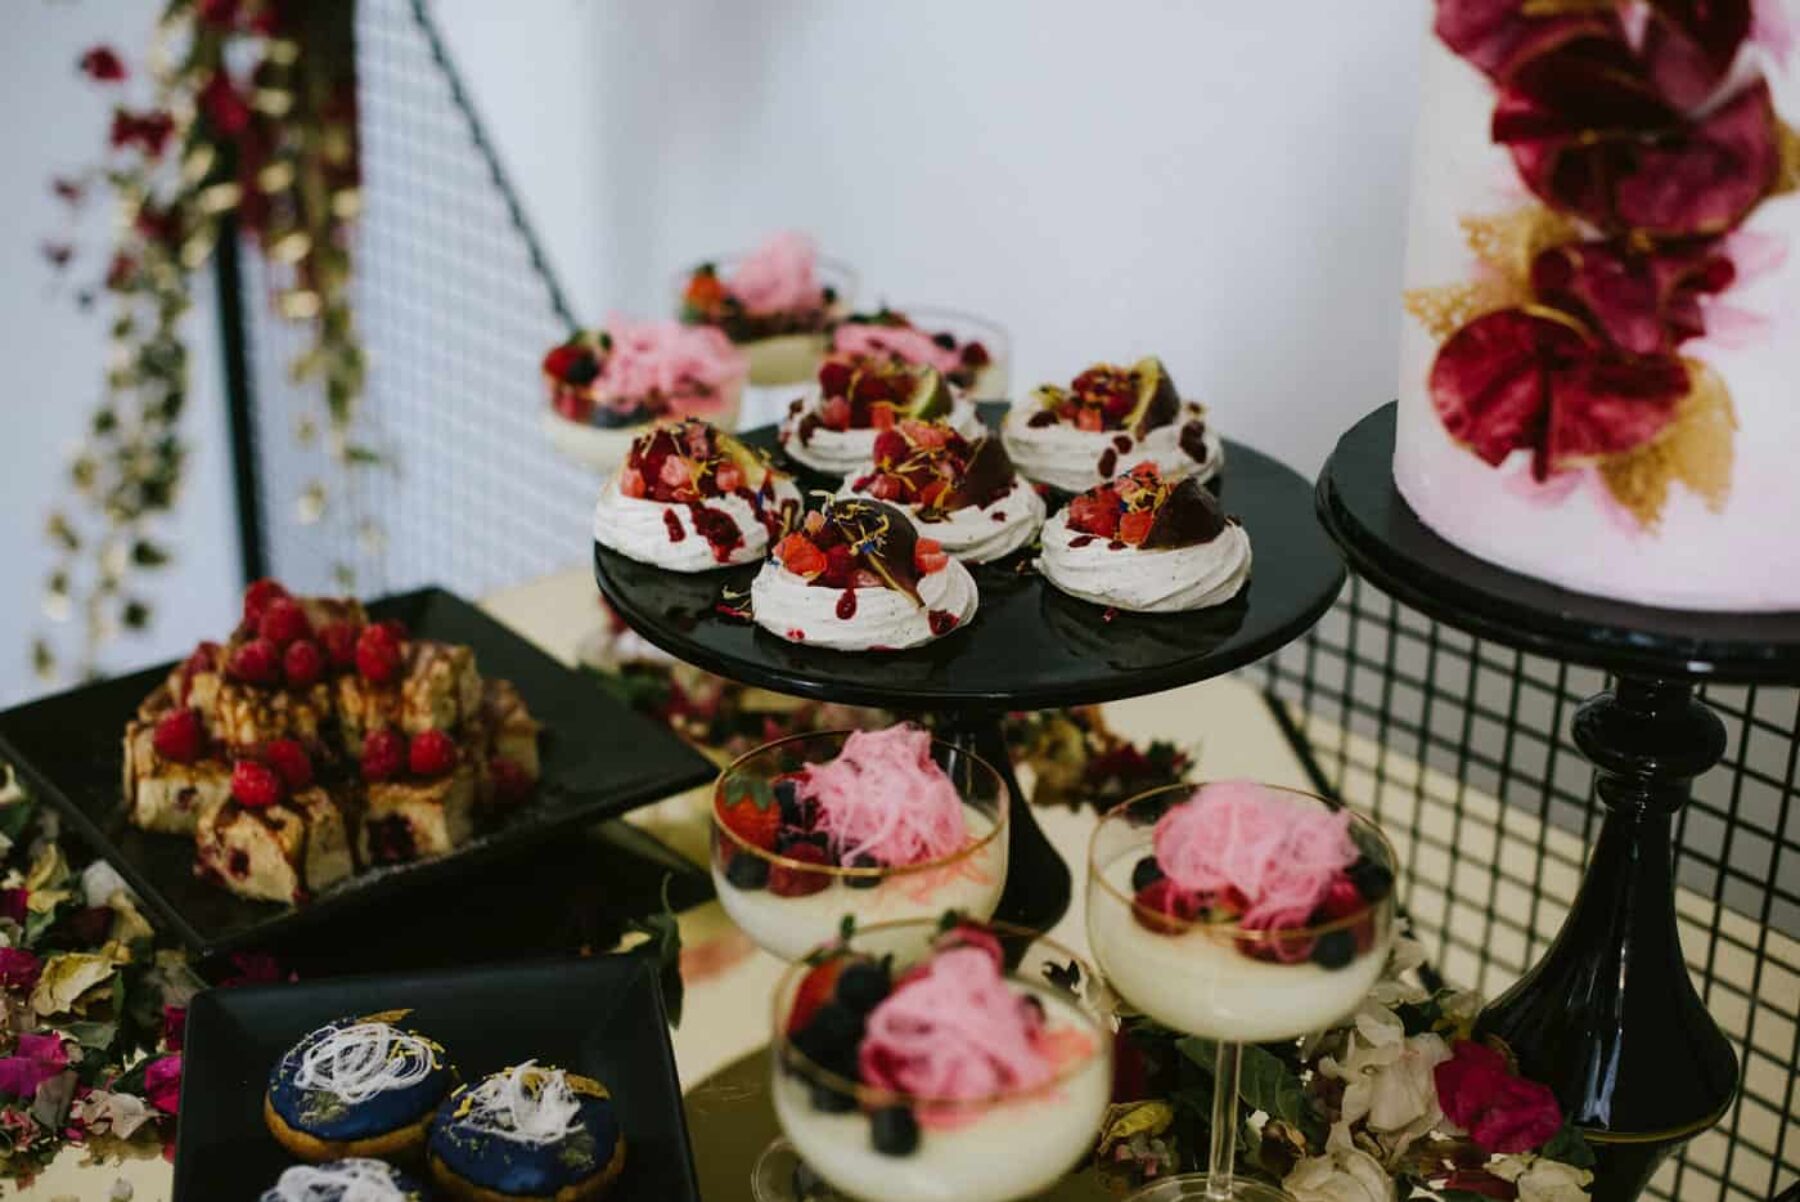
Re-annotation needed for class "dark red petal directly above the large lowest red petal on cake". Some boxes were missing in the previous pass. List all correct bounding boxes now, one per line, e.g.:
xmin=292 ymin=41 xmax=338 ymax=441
xmin=1532 ymin=239 xmax=1737 ymax=354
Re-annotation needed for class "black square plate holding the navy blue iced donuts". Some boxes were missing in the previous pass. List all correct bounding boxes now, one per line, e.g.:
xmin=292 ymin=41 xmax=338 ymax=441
xmin=175 ymin=955 xmax=700 ymax=1202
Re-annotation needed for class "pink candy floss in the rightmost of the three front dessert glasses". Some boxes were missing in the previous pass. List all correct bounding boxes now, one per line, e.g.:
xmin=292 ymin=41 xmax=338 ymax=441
xmin=1154 ymin=781 xmax=1357 ymax=928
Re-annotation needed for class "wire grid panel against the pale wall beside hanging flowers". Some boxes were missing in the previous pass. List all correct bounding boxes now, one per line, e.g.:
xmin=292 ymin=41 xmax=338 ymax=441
xmin=243 ymin=0 xmax=598 ymax=596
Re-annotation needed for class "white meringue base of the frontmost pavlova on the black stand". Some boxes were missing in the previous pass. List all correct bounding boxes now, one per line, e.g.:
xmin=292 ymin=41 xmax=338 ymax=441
xmin=751 ymin=560 xmax=979 ymax=651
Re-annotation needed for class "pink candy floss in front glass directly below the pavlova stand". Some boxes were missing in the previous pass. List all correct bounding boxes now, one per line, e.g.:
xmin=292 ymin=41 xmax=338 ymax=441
xmin=799 ymin=723 xmax=968 ymax=866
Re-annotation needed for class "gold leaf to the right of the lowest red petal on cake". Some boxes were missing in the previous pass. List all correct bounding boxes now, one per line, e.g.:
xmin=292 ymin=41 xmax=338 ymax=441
xmin=1600 ymin=358 xmax=1737 ymax=531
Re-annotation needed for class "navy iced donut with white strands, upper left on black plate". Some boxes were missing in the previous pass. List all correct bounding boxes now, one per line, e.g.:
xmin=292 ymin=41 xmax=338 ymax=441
xmin=263 ymin=1009 xmax=455 ymax=1161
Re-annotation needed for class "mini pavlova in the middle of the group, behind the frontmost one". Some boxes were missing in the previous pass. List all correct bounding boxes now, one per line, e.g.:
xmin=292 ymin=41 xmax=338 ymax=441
xmin=841 ymin=419 xmax=1044 ymax=563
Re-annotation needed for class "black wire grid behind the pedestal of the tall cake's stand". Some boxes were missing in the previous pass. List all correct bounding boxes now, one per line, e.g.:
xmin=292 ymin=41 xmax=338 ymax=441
xmin=1251 ymin=579 xmax=1800 ymax=1200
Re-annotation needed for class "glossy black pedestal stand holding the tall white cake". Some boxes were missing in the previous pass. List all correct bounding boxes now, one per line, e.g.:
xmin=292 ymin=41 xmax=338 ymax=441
xmin=1318 ymin=405 xmax=1800 ymax=1202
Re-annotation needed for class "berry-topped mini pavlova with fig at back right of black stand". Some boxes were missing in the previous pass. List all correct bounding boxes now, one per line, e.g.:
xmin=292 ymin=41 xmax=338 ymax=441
xmin=1001 ymin=356 xmax=1226 ymax=493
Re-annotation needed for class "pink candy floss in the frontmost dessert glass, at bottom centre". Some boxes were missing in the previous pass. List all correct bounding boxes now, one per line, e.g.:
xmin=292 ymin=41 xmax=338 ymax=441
xmin=859 ymin=946 xmax=1057 ymax=1099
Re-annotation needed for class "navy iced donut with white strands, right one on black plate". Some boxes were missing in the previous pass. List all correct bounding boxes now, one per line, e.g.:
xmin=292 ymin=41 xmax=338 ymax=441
xmin=427 ymin=1060 xmax=625 ymax=1202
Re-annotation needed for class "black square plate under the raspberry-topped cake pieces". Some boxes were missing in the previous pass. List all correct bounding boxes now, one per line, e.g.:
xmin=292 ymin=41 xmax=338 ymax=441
xmin=0 ymin=588 xmax=718 ymax=955
